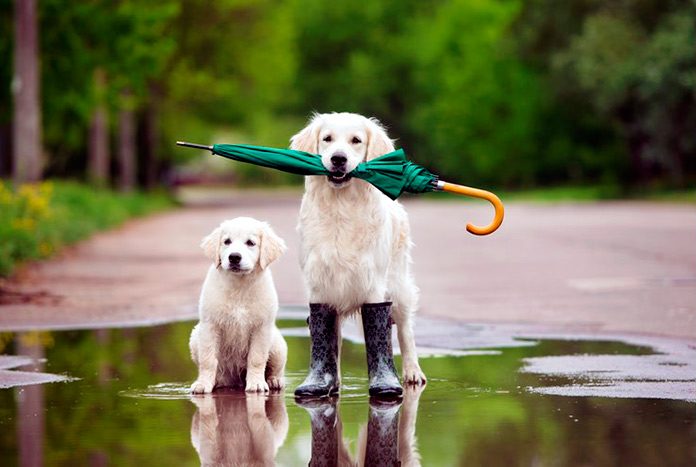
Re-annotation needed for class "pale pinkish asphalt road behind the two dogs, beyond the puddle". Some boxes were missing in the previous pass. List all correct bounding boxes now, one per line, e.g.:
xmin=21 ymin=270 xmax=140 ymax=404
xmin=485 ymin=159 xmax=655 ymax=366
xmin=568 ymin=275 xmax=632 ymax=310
xmin=0 ymin=188 xmax=696 ymax=341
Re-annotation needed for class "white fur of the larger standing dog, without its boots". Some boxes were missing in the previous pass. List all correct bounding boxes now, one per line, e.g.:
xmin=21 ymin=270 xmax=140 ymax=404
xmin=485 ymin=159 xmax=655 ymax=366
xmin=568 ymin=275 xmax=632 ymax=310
xmin=290 ymin=113 xmax=426 ymax=384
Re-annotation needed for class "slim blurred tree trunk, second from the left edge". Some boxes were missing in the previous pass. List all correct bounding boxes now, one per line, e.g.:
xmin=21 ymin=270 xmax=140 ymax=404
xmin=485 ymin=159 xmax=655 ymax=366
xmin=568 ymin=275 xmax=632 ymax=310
xmin=87 ymin=69 xmax=110 ymax=186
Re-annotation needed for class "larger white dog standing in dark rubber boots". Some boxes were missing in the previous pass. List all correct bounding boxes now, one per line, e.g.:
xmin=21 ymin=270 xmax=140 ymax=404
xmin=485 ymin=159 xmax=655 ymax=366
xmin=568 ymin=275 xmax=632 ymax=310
xmin=290 ymin=113 xmax=426 ymax=396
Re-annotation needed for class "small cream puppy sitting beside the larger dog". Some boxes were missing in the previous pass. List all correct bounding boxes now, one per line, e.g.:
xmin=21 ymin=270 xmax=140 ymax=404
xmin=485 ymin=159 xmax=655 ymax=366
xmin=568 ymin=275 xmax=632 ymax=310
xmin=189 ymin=217 xmax=287 ymax=393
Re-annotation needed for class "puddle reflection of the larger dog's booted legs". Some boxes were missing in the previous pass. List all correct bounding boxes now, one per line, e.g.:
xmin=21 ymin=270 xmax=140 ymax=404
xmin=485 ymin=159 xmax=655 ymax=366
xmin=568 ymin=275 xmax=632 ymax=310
xmin=297 ymin=386 xmax=424 ymax=467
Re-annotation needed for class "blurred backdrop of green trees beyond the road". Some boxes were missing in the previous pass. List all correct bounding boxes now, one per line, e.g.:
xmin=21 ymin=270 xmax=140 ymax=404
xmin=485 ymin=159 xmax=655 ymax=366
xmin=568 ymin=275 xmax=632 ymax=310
xmin=0 ymin=0 xmax=696 ymax=192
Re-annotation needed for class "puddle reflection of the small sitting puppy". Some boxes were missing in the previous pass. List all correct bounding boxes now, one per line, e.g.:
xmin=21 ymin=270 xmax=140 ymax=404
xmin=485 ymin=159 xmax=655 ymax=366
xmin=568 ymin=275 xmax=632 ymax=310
xmin=191 ymin=393 xmax=288 ymax=466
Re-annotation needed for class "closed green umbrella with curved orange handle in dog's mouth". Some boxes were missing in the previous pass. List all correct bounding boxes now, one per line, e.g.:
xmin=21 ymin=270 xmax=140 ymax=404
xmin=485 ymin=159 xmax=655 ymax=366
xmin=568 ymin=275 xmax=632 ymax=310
xmin=176 ymin=141 xmax=505 ymax=235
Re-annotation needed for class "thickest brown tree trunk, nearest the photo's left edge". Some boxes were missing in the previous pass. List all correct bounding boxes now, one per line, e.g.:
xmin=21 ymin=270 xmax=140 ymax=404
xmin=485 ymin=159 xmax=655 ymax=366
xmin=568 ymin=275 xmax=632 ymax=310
xmin=12 ymin=0 xmax=43 ymax=183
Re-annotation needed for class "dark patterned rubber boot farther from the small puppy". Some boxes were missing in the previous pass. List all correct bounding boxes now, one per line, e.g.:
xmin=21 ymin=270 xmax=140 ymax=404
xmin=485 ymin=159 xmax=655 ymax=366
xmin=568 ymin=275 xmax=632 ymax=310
xmin=362 ymin=302 xmax=403 ymax=398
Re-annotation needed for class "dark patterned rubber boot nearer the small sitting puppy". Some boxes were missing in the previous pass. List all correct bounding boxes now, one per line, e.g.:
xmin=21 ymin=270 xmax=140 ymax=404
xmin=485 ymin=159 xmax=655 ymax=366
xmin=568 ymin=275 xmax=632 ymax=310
xmin=295 ymin=303 xmax=339 ymax=397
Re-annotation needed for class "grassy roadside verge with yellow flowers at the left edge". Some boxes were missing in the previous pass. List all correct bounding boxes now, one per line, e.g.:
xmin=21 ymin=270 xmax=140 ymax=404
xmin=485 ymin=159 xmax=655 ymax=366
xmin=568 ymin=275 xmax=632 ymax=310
xmin=0 ymin=181 xmax=172 ymax=277
